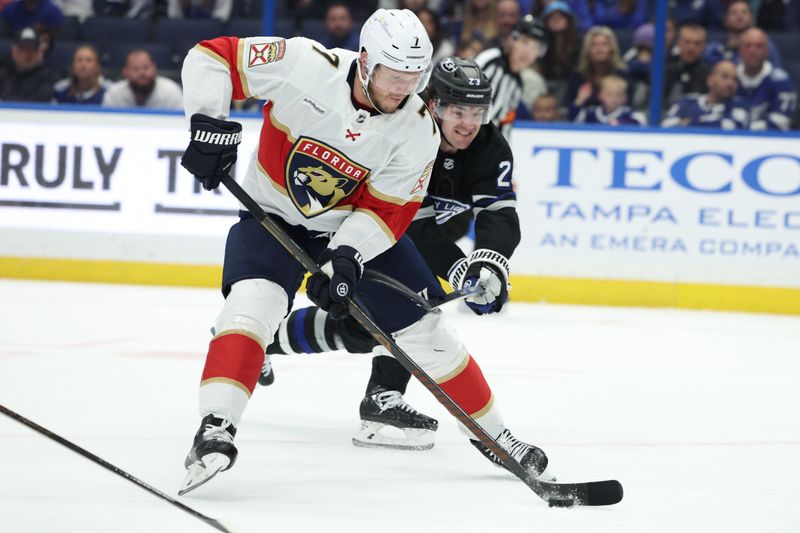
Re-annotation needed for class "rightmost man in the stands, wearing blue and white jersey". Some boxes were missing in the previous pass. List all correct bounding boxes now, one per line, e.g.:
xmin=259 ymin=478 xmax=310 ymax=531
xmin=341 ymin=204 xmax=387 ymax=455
xmin=736 ymin=28 xmax=797 ymax=131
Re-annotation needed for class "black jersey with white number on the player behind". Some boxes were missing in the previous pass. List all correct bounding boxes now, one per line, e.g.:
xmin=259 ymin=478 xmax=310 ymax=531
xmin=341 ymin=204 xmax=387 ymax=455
xmin=407 ymin=123 xmax=520 ymax=279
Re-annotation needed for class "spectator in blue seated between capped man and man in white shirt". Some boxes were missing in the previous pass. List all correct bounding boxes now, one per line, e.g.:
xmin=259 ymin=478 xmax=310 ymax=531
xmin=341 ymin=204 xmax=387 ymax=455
xmin=53 ymin=44 xmax=111 ymax=105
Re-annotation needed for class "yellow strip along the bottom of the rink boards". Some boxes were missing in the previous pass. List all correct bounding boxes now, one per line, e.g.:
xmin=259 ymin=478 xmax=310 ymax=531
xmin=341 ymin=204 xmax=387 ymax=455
xmin=0 ymin=257 xmax=800 ymax=315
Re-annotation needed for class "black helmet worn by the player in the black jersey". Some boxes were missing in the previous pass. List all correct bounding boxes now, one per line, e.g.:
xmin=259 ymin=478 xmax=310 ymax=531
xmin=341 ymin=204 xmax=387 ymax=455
xmin=428 ymin=57 xmax=492 ymax=107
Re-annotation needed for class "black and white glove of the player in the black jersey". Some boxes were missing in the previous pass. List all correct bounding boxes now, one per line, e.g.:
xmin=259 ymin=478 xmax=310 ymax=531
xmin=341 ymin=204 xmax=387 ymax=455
xmin=450 ymin=248 xmax=509 ymax=315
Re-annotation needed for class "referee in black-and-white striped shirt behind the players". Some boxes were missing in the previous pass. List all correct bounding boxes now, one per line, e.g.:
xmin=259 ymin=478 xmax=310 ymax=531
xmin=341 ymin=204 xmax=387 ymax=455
xmin=475 ymin=15 xmax=547 ymax=142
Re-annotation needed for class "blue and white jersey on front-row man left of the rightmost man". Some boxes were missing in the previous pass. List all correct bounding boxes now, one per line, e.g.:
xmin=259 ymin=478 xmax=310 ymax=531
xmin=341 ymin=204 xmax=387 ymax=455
xmin=661 ymin=94 xmax=750 ymax=130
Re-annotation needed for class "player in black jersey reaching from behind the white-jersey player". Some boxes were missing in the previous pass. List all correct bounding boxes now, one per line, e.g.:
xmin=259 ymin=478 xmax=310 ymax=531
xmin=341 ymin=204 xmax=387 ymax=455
xmin=259 ymin=57 xmax=541 ymax=472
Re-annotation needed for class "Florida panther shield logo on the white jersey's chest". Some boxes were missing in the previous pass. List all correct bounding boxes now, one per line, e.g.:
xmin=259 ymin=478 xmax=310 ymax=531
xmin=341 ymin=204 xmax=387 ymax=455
xmin=286 ymin=137 xmax=369 ymax=218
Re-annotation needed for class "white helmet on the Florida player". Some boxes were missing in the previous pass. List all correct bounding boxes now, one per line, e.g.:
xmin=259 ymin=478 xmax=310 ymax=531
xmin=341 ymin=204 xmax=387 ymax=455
xmin=358 ymin=9 xmax=433 ymax=93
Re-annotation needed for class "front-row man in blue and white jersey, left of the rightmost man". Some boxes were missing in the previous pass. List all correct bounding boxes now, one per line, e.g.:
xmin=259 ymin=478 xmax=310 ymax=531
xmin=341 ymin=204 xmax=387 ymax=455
xmin=661 ymin=59 xmax=750 ymax=130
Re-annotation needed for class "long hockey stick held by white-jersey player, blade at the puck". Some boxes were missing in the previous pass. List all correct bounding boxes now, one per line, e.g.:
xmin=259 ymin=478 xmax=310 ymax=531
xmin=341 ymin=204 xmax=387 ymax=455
xmin=221 ymin=175 xmax=622 ymax=507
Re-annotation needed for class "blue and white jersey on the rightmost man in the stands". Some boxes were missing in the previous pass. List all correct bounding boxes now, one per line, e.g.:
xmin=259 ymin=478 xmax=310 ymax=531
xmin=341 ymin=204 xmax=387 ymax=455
xmin=736 ymin=61 xmax=797 ymax=131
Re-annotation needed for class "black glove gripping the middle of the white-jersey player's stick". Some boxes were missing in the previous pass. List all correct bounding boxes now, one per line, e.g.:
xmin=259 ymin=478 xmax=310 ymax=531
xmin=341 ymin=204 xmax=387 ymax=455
xmin=306 ymin=246 xmax=364 ymax=320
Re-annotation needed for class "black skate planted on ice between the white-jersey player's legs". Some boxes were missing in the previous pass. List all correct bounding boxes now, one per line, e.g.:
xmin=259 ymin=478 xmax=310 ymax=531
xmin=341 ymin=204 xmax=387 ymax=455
xmin=353 ymin=387 xmax=439 ymax=450
